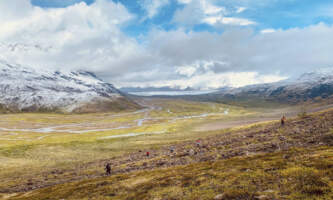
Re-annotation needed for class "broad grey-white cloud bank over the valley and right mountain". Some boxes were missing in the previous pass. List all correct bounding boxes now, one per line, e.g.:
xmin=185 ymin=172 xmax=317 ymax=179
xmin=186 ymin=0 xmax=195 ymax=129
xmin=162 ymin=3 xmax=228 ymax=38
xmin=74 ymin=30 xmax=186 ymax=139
xmin=123 ymin=24 xmax=333 ymax=88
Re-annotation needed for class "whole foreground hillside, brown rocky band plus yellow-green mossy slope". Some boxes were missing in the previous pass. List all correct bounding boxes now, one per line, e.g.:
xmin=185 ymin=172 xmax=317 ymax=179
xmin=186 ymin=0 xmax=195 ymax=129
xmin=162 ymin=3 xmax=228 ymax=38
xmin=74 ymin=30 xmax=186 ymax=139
xmin=0 ymin=104 xmax=333 ymax=199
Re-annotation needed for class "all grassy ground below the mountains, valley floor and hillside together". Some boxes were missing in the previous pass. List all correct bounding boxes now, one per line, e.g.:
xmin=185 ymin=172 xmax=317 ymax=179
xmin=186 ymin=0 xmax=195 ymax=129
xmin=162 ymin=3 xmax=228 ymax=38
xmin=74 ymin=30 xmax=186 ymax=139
xmin=0 ymin=99 xmax=333 ymax=199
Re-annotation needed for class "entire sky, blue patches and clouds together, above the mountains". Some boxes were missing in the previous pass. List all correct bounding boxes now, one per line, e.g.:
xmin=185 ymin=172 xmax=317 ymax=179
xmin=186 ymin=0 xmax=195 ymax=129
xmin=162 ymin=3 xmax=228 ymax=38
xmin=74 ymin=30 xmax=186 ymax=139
xmin=0 ymin=0 xmax=333 ymax=89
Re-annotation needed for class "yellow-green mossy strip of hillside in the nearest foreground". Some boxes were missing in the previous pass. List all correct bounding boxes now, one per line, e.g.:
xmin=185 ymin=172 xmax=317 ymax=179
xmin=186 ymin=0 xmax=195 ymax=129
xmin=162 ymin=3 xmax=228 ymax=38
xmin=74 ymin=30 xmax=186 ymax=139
xmin=8 ymin=147 xmax=333 ymax=200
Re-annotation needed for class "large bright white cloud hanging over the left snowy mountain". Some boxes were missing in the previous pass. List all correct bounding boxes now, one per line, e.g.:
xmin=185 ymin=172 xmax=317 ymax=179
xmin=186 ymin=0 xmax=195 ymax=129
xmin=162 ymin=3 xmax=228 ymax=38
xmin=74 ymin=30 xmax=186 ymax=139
xmin=0 ymin=0 xmax=140 ymax=73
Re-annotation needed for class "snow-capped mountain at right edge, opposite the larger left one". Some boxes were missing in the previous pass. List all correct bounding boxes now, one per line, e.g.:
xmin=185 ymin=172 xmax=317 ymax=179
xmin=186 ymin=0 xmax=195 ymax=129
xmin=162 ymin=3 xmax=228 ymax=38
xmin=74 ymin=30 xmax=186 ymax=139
xmin=219 ymin=70 xmax=333 ymax=102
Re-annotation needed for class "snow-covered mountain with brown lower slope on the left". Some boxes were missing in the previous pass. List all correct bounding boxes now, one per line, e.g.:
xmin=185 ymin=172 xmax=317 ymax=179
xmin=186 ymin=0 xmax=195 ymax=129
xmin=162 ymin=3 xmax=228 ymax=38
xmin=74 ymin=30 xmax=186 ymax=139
xmin=0 ymin=61 xmax=139 ymax=112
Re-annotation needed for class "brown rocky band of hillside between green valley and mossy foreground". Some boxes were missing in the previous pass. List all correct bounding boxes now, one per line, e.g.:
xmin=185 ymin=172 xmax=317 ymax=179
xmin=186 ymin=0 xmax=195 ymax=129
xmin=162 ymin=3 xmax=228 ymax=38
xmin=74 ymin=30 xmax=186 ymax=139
xmin=0 ymin=106 xmax=333 ymax=193
